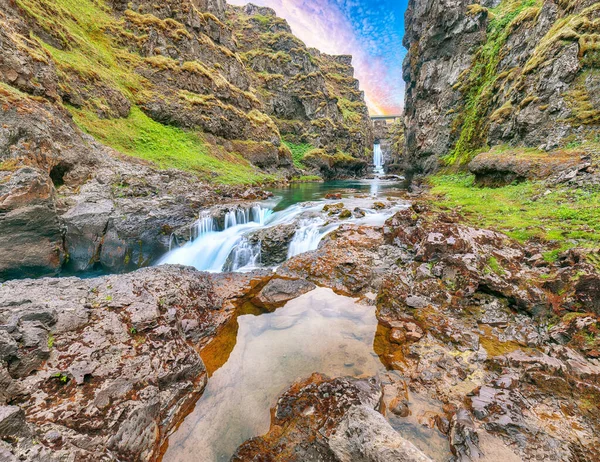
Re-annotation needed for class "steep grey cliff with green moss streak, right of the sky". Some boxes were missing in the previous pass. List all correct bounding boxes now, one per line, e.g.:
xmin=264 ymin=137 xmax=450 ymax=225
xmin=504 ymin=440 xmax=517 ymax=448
xmin=404 ymin=0 xmax=600 ymax=173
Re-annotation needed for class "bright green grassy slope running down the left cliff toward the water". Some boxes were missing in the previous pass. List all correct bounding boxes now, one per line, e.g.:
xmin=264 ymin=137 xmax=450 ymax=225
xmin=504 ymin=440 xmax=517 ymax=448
xmin=16 ymin=0 xmax=272 ymax=184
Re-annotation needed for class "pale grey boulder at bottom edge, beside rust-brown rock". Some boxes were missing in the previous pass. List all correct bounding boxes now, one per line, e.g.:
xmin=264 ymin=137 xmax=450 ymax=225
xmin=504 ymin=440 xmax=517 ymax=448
xmin=329 ymin=406 xmax=432 ymax=462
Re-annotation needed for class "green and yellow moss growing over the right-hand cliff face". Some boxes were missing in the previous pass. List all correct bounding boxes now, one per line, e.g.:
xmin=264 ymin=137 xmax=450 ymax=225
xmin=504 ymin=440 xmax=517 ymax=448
xmin=444 ymin=0 xmax=600 ymax=167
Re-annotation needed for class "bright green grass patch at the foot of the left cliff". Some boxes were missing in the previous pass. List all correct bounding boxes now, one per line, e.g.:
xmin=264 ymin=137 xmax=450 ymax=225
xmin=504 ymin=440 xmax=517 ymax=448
xmin=70 ymin=106 xmax=272 ymax=184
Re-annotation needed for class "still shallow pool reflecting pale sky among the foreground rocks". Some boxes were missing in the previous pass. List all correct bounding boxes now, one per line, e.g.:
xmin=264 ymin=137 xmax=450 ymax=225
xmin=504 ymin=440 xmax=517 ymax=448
xmin=163 ymin=288 xmax=382 ymax=462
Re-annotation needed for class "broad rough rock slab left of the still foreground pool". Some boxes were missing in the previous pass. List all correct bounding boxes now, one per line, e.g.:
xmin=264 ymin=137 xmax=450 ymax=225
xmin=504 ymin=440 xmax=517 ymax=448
xmin=0 ymin=267 xmax=269 ymax=461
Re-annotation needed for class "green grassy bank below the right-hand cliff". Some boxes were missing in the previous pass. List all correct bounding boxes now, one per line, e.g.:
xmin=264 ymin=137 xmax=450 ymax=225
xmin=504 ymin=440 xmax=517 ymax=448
xmin=430 ymin=174 xmax=600 ymax=247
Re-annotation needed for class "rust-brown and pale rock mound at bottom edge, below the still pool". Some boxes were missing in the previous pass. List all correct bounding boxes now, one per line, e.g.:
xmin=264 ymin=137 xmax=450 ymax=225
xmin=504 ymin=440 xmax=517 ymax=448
xmin=232 ymin=374 xmax=431 ymax=462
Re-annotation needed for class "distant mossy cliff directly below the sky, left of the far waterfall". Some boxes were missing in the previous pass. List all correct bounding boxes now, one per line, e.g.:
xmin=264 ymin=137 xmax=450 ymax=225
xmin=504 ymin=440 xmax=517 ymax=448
xmin=227 ymin=4 xmax=373 ymax=158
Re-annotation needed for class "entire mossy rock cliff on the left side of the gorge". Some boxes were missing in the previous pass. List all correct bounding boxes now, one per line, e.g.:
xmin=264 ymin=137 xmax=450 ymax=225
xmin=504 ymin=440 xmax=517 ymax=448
xmin=0 ymin=0 xmax=371 ymax=279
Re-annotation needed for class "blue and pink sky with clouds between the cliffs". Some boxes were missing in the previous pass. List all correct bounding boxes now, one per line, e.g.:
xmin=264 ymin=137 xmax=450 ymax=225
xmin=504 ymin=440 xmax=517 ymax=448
xmin=228 ymin=0 xmax=408 ymax=115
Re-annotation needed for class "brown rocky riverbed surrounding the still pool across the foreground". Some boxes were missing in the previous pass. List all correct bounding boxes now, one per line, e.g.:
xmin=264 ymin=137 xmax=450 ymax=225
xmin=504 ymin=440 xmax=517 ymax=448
xmin=0 ymin=193 xmax=600 ymax=461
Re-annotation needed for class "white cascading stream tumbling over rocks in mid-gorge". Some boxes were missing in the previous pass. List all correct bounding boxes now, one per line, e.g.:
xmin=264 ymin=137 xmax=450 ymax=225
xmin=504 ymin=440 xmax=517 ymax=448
xmin=158 ymin=171 xmax=407 ymax=272
